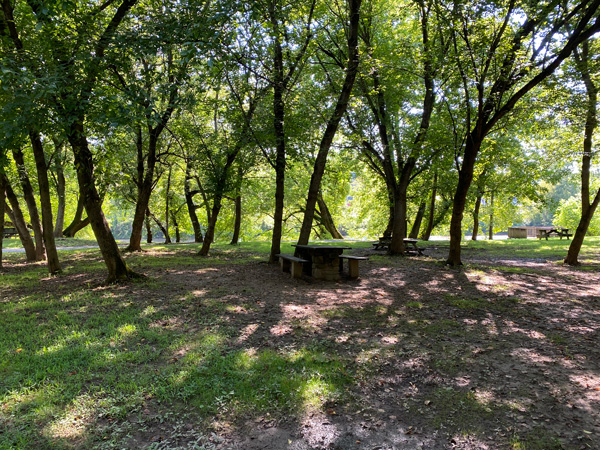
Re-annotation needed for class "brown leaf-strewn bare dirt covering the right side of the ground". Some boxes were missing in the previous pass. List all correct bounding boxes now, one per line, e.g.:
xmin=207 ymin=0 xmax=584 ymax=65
xmin=131 ymin=248 xmax=600 ymax=450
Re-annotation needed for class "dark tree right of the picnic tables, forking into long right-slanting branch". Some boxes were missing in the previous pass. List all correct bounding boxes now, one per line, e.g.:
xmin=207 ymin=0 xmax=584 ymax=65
xmin=442 ymin=0 xmax=600 ymax=266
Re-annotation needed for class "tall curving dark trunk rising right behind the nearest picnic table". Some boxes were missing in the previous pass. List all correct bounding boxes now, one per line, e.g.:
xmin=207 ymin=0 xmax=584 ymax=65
xmin=298 ymin=0 xmax=362 ymax=244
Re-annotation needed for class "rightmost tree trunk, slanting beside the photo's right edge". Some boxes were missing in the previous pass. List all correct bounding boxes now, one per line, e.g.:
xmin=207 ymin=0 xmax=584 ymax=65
xmin=564 ymin=41 xmax=600 ymax=266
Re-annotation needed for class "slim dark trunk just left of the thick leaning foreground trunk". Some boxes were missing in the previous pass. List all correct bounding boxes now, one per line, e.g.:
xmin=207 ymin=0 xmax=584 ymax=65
xmin=29 ymin=132 xmax=62 ymax=274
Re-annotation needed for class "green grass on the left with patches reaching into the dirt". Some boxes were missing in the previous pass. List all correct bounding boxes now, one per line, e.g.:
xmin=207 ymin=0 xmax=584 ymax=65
xmin=0 ymin=239 xmax=600 ymax=450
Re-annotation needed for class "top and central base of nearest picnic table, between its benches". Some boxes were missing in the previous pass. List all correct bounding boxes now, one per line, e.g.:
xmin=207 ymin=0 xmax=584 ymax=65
xmin=292 ymin=244 xmax=351 ymax=281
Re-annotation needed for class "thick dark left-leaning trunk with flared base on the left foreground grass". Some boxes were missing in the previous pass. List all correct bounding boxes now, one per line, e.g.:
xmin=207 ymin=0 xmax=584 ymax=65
xmin=68 ymin=122 xmax=138 ymax=283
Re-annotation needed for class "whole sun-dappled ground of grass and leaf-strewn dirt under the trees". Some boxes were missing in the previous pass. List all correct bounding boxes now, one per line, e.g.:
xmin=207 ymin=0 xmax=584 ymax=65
xmin=0 ymin=242 xmax=600 ymax=450
